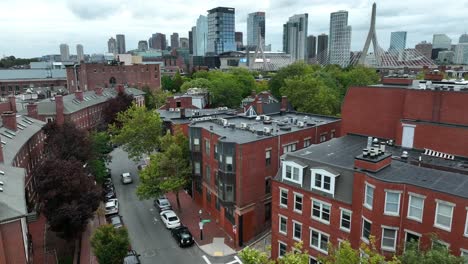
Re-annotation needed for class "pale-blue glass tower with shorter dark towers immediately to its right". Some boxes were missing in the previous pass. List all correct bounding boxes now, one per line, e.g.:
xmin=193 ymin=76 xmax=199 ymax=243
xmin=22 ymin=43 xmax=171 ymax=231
xmin=283 ymin=13 xmax=309 ymax=61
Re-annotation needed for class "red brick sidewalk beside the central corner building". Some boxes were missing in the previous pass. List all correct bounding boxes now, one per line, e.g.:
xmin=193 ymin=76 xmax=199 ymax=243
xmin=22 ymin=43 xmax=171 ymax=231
xmin=166 ymin=191 xmax=236 ymax=256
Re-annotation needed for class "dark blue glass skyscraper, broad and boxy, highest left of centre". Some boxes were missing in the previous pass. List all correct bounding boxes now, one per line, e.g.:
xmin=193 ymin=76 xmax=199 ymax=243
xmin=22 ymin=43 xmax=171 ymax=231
xmin=206 ymin=7 xmax=236 ymax=54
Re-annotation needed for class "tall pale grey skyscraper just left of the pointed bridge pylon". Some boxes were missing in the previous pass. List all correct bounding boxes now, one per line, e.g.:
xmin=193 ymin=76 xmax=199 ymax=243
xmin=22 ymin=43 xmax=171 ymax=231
xmin=328 ymin=11 xmax=351 ymax=68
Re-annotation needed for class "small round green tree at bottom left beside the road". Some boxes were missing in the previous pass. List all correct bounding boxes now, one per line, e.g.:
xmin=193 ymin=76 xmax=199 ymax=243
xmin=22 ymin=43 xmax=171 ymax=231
xmin=91 ymin=225 xmax=130 ymax=264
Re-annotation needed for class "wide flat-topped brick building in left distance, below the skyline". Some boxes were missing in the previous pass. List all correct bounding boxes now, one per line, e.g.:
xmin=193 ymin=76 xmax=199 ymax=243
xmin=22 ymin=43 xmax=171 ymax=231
xmin=66 ymin=63 xmax=161 ymax=92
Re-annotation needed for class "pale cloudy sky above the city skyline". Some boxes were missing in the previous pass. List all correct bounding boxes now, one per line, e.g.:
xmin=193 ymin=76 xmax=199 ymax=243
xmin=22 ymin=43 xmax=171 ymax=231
xmin=0 ymin=0 xmax=468 ymax=57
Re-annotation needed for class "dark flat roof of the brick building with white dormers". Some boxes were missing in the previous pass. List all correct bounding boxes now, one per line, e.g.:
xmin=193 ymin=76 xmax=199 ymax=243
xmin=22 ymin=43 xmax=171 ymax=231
xmin=287 ymin=135 xmax=468 ymax=198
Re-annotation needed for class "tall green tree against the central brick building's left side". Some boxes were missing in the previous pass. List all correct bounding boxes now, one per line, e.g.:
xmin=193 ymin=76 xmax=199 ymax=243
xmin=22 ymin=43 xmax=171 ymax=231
xmin=137 ymin=129 xmax=191 ymax=210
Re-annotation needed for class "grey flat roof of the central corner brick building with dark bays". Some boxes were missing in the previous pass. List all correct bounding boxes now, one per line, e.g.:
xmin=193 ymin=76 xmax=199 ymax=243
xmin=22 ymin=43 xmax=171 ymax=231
xmin=190 ymin=112 xmax=340 ymax=144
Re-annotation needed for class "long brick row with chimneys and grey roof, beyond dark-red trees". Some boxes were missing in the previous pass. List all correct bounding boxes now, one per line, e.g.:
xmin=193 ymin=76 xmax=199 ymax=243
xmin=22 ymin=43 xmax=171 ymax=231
xmin=20 ymin=85 xmax=145 ymax=129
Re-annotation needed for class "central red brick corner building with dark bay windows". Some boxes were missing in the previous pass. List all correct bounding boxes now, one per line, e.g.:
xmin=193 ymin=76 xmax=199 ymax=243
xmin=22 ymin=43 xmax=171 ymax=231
xmin=189 ymin=106 xmax=340 ymax=246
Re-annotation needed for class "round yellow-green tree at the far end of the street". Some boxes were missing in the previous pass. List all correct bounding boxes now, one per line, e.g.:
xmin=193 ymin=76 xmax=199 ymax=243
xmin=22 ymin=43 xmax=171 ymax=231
xmin=109 ymin=104 xmax=162 ymax=160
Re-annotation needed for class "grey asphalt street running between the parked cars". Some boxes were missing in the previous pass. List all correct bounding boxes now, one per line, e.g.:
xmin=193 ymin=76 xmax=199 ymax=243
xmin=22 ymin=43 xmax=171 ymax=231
xmin=109 ymin=148 xmax=239 ymax=264
